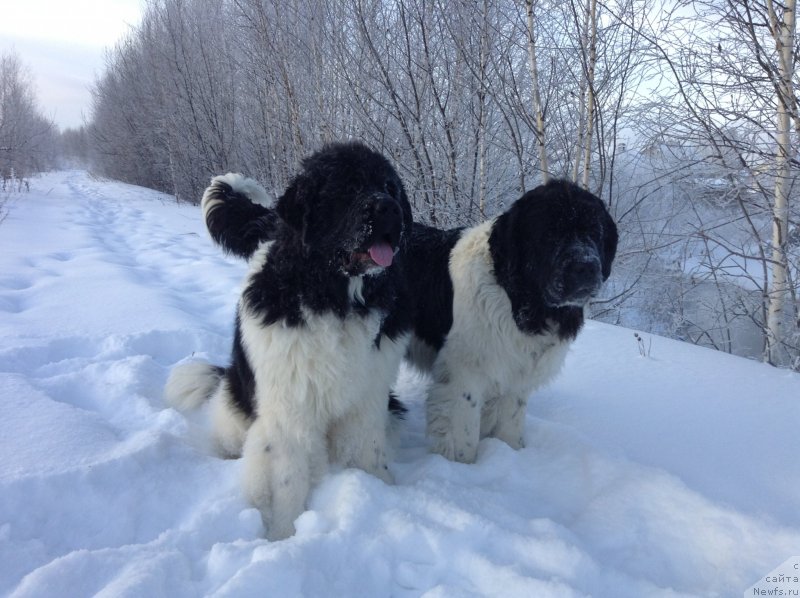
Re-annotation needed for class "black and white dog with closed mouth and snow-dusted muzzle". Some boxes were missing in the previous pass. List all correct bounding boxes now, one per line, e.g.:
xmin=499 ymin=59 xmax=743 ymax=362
xmin=407 ymin=181 xmax=617 ymax=463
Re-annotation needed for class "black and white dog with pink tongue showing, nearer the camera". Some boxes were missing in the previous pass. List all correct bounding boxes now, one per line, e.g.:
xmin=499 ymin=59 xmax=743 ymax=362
xmin=165 ymin=143 xmax=411 ymax=539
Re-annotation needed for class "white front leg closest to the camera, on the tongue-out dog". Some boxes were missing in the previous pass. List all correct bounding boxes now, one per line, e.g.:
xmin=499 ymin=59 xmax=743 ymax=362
xmin=243 ymin=412 xmax=327 ymax=540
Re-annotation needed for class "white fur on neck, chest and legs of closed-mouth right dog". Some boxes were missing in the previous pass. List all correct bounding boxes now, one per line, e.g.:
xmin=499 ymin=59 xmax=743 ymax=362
xmin=426 ymin=220 xmax=570 ymax=463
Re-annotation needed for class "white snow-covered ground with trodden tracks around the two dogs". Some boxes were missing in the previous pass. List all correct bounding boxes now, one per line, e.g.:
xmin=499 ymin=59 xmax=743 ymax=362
xmin=0 ymin=171 xmax=800 ymax=598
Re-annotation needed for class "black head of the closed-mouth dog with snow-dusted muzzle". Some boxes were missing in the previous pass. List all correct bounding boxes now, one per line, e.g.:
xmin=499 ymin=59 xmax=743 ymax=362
xmin=490 ymin=181 xmax=617 ymax=332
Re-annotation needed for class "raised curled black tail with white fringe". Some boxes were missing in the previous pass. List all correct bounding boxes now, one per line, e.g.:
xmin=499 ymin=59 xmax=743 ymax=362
xmin=200 ymin=172 xmax=278 ymax=259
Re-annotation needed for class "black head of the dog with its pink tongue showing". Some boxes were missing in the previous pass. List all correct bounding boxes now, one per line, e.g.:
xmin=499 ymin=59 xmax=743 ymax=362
xmin=276 ymin=142 xmax=411 ymax=276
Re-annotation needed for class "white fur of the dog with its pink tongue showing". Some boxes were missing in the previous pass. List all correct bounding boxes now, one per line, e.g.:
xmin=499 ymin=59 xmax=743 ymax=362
xmin=165 ymin=243 xmax=408 ymax=539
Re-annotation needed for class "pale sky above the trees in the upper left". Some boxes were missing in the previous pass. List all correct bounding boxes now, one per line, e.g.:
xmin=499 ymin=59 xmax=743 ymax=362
xmin=0 ymin=0 xmax=144 ymax=128
